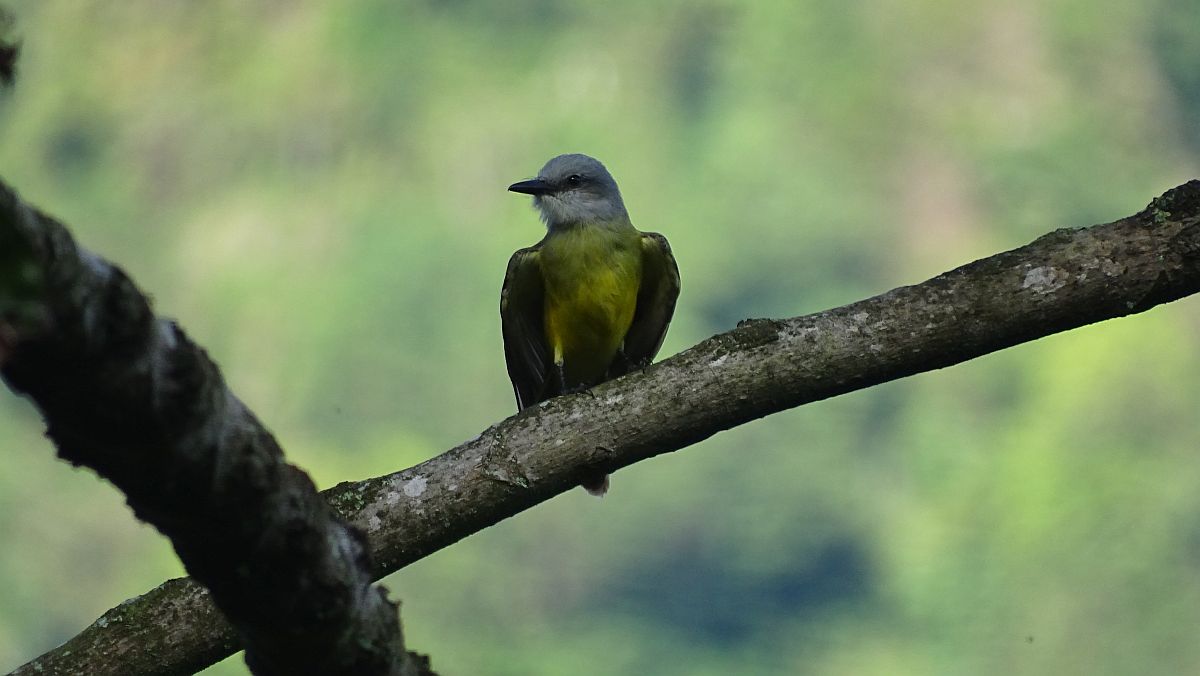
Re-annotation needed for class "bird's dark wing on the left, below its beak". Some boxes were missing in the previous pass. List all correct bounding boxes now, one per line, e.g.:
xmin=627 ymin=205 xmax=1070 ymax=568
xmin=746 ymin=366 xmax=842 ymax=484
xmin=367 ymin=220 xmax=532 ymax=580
xmin=500 ymin=246 xmax=551 ymax=411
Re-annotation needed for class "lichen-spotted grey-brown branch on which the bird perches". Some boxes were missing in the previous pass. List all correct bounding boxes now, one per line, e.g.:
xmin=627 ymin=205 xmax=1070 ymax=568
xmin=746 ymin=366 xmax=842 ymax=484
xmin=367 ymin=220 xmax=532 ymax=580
xmin=9 ymin=181 xmax=1200 ymax=676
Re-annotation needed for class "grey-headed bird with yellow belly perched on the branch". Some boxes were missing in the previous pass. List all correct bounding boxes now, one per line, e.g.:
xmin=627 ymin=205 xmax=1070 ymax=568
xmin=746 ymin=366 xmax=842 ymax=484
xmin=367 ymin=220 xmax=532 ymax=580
xmin=500 ymin=154 xmax=679 ymax=496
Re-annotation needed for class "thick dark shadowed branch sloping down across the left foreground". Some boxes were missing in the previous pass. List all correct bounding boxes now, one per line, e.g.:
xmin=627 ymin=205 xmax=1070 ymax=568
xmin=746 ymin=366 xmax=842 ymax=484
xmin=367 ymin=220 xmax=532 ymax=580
xmin=0 ymin=184 xmax=432 ymax=676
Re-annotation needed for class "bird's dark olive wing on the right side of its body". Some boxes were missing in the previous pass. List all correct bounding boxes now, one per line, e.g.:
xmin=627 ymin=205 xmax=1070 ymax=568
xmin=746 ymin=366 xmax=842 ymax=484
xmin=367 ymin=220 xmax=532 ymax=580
xmin=614 ymin=233 xmax=679 ymax=375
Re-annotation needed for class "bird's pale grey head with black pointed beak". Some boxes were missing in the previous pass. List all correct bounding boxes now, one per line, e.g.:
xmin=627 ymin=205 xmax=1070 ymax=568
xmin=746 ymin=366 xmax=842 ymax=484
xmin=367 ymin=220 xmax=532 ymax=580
xmin=509 ymin=154 xmax=629 ymax=228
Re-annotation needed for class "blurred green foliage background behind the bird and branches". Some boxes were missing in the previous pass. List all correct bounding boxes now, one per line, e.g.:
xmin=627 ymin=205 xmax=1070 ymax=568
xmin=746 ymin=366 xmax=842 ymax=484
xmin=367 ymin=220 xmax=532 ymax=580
xmin=0 ymin=0 xmax=1200 ymax=676
